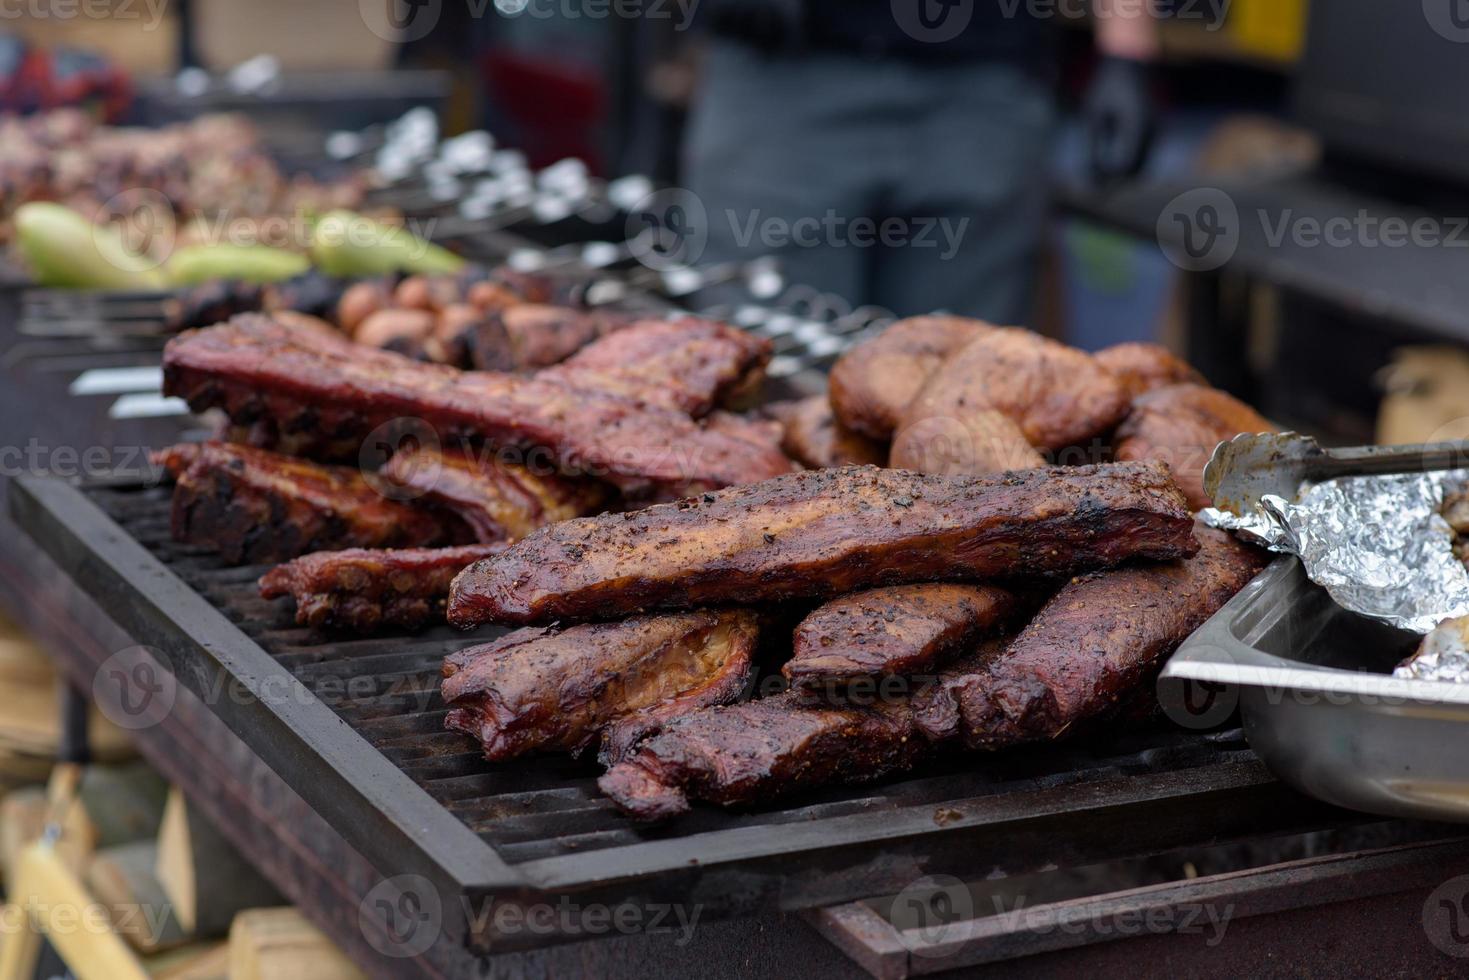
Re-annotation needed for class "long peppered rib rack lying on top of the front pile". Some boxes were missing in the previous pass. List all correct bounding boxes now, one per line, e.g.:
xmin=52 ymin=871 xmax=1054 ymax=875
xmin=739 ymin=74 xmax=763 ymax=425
xmin=450 ymin=463 xmax=1199 ymax=626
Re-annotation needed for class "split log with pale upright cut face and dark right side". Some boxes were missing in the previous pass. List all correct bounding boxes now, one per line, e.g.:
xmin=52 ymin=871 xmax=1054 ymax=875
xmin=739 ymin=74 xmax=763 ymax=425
xmin=156 ymin=789 xmax=282 ymax=939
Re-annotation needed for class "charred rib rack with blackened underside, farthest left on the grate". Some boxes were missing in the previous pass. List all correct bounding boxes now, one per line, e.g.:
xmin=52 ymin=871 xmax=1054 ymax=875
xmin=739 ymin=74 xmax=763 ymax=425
xmin=154 ymin=442 xmax=463 ymax=564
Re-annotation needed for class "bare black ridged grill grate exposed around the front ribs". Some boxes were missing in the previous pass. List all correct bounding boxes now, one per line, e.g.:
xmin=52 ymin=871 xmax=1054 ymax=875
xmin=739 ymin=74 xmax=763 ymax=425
xmin=91 ymin=488 xmax=1280 ymax=864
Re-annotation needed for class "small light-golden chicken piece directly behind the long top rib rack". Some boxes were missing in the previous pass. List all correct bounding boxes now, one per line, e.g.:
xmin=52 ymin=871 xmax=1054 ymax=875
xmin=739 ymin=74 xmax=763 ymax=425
xmin=889 ymin=408 xmax=1046 ymax=476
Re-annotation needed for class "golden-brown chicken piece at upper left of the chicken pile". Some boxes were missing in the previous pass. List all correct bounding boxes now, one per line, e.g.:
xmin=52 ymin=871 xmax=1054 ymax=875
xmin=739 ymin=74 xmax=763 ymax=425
xmin=830 ymin=316 xmax=995 ymax=441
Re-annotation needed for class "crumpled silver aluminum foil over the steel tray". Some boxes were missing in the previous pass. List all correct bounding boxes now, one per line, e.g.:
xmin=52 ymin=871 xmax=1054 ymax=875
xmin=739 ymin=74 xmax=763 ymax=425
xmin=1200 ymin=470 xmax=1469 ymax=637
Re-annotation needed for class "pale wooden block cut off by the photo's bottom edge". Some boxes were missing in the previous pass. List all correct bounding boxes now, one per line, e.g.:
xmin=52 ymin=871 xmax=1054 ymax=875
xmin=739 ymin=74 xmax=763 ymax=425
xmin=229 ymin=908 xmax=366 ymax=980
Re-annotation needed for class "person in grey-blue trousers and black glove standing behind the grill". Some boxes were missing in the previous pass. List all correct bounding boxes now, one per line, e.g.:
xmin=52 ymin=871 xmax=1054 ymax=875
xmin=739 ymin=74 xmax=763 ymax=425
xmin=683 ymin=0 xmax=1159 ymax=323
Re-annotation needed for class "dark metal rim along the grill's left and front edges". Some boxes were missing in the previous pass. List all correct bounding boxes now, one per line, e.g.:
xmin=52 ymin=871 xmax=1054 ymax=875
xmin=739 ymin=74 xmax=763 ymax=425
xmin=10 ymin=478 xmax=1360 ymax=951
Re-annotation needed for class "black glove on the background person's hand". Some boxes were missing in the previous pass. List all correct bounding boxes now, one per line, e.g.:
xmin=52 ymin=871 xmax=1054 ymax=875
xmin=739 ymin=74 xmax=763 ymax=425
xmin=1086 ymin=56 xmax=1158 ymax=184
